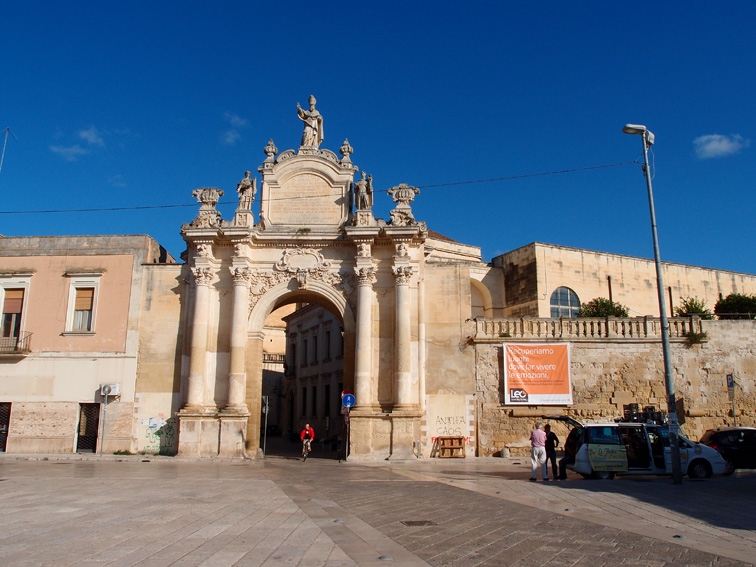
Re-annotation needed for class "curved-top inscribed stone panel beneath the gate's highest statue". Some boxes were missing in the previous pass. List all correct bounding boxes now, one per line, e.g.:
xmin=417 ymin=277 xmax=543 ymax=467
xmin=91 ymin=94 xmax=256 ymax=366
xmin=259 ymin=149 xmax=357 ymax=233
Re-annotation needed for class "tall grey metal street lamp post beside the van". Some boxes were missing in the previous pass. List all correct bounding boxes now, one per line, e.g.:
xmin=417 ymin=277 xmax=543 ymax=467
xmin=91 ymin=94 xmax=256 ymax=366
xmin=622 ymin=124 xmax=682 ymax=484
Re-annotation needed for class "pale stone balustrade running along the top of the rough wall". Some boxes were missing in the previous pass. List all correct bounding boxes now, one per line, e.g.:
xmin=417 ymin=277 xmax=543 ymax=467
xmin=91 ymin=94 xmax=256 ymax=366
xmin=470 ymin=316 xmax=703 ymax=343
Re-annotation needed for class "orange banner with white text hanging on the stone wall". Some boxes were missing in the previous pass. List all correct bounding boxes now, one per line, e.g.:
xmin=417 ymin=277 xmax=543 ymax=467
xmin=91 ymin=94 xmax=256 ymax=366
xmin=504 ymin=343 xmax=572 ymax=405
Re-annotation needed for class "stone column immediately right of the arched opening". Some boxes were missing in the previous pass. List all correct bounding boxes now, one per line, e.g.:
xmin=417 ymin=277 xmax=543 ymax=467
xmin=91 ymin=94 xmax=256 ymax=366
xmin=354 ymin=262 xmax=377 ymax=412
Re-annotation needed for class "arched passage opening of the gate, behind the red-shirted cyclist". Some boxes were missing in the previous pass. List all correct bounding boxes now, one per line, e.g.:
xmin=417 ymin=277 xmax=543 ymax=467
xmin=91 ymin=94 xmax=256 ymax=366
xmin=247 ymin=284 xmax=354 ymax=458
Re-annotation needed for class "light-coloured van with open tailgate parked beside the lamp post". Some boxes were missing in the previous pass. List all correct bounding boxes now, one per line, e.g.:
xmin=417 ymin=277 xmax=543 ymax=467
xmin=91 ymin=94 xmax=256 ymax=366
xmin=543 ymin=415 xmax=727 ymax=479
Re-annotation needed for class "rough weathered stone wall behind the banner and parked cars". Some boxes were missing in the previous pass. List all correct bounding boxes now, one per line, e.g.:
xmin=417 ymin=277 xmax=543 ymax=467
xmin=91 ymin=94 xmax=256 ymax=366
xmin=475 ymin=321 xmax=756 ymax=456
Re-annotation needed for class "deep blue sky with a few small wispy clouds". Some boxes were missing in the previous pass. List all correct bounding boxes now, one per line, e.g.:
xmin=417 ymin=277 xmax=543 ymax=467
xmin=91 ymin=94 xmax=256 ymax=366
xmin=0 ymin=0 xmax=756 ymax=273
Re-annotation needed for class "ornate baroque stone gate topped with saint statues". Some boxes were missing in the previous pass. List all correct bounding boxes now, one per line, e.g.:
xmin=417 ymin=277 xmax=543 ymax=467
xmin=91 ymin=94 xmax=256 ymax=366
xmin=177 ymin=107 xmax=427 ymax=458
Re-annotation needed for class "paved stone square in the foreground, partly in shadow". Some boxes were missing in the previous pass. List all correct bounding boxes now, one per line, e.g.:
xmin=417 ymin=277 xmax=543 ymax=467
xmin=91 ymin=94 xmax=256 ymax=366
xmin=0 ymin=453 xmax=756 ymax=567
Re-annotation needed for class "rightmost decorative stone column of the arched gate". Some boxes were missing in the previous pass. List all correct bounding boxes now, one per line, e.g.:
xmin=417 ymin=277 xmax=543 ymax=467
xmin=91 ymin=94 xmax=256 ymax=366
xmin=392 ymin=265 xmax=415 ymax=411
